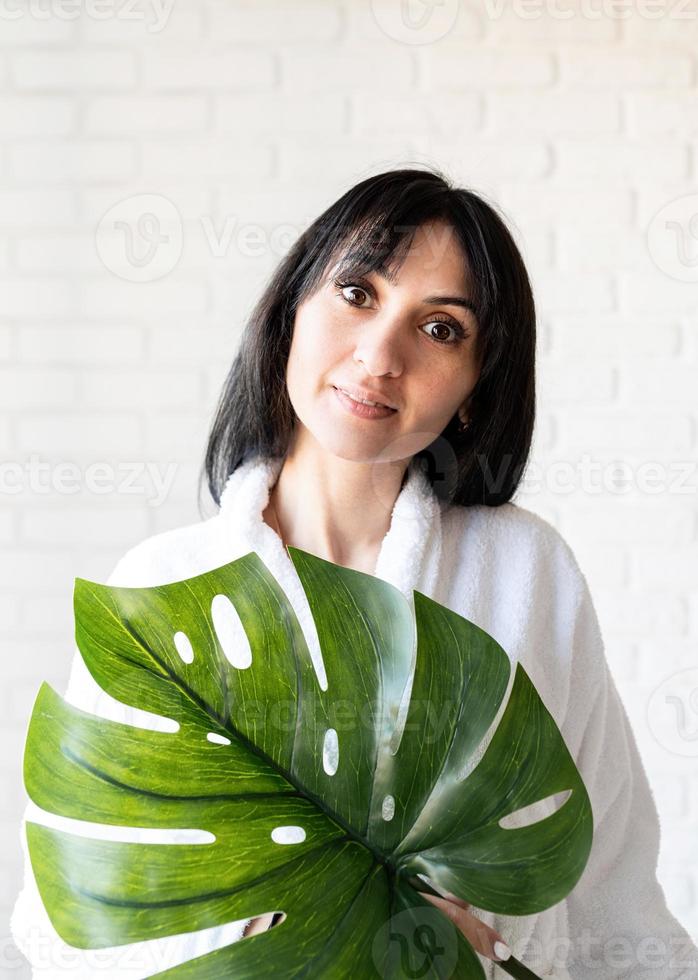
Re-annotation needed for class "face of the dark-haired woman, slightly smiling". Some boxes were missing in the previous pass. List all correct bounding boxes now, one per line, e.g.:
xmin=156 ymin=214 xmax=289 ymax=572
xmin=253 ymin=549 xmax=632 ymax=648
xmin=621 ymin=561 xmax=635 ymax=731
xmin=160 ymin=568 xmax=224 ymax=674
xmin=286 ymin=222 xmax=481 ymax=462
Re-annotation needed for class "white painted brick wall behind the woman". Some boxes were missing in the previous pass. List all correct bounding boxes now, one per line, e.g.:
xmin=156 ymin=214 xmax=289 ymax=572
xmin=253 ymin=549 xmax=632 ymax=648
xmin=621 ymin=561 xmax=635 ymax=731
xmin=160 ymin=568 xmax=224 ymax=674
xmin=0 ymin=0 xmax=698 ymax=964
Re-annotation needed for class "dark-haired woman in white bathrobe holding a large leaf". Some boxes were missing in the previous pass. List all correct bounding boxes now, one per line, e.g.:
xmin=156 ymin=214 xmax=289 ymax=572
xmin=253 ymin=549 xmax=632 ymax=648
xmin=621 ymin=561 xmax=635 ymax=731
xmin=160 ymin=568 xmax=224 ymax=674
xmin=13 ymin=169 xmax=696 ymax=980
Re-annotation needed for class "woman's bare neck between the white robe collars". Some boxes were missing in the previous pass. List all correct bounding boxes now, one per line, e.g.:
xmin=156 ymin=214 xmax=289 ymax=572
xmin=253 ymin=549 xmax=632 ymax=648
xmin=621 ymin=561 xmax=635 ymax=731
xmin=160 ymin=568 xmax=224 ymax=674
xmin=263 ymin=429 xmax=409 ymax=573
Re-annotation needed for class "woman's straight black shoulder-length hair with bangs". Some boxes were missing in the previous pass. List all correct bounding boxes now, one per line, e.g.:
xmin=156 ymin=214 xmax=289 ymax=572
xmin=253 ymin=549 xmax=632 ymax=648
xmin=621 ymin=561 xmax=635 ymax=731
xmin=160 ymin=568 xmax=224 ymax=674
xmin=199 ymin=169 xmax=536 ymax=507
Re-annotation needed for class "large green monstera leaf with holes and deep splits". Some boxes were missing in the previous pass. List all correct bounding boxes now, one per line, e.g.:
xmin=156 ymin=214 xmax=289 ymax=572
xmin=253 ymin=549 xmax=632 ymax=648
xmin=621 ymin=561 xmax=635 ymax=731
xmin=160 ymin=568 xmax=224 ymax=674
xmin=24 ymin=547 xmax=593 ymax=980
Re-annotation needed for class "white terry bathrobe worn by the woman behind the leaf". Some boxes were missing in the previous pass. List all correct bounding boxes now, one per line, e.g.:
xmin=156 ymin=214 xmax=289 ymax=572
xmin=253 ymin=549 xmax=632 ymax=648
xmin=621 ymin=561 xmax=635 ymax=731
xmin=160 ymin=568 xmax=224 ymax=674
xmin=12 ymin=459 xmax=698 ymax=980
